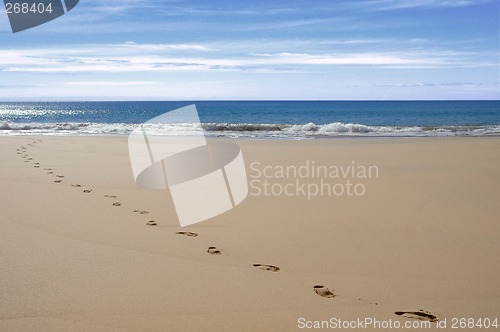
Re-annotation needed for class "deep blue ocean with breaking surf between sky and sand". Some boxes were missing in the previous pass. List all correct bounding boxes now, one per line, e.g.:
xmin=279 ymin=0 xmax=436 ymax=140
xmin=0 ymin=101 xmax=500 ymax=138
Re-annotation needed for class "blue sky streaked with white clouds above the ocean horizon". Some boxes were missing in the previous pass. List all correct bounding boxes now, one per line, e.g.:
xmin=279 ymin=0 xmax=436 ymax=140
xmin=0 ymin=0 xmax=500 ymax=101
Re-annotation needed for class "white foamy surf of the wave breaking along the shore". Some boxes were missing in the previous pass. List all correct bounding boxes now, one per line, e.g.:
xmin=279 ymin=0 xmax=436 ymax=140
xmin=0 ymin=121 xmax=500 ymax=139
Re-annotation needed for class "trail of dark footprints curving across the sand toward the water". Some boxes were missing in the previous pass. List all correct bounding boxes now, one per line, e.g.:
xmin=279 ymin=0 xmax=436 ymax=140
xmin=17 ymin=139 xmax=439 ymax=322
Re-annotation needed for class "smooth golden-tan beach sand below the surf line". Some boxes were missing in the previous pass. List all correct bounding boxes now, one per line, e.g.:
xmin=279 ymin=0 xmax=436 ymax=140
xmin=0 ymin=137 xmax=500 ymax=331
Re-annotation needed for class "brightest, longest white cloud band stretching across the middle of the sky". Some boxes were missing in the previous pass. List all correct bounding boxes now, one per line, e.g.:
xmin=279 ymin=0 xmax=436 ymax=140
xmin=0 ymin=41 xmax=496 ymax=73
